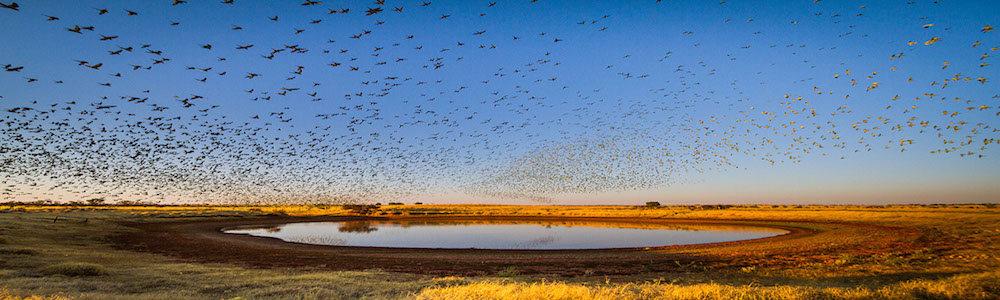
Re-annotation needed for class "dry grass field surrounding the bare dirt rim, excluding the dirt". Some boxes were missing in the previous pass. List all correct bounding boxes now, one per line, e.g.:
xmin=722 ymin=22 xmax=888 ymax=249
xmin=0 ymin=205 xmax=1000 ymax=299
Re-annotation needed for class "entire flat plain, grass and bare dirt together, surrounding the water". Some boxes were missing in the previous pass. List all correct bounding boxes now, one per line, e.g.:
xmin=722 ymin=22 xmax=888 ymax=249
xmin=0 ymin=205 xmax=1000 ymax=299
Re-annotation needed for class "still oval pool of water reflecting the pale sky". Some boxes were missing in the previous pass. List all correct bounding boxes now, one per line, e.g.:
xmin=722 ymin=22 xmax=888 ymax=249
xmin=223 ymin=220 xmax=788 ymax=250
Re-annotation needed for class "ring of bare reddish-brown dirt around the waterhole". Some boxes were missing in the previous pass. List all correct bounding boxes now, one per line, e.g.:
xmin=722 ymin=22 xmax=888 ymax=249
xmin=112 ymin=216 xmax=914 ymax=276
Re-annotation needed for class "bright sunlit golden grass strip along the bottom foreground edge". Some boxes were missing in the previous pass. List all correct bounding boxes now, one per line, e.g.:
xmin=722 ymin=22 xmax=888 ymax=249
xmin=415 ymin=272 xmax=1000 ymax=300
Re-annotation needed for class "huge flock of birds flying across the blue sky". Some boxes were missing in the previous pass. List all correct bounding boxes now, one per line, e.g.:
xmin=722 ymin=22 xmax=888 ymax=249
xmin=0 ymin=0 xmax=1000 ymax=204
